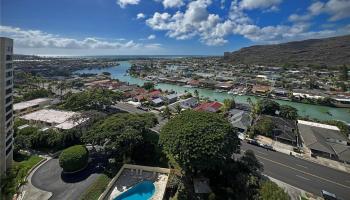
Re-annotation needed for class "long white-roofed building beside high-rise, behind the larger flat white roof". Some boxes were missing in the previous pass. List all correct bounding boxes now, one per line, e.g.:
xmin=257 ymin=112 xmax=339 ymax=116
xmin=13 ymin=98 xmax=52 ymax=116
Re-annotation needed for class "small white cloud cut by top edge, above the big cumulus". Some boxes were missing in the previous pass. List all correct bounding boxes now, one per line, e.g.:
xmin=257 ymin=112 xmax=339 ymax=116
xmin=239 ymin=0 xmax=282 ymax=10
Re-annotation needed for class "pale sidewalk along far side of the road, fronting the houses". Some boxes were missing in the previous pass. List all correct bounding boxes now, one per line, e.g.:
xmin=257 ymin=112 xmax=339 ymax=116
xmin=256 ymin=135 xmax=350 ymax=173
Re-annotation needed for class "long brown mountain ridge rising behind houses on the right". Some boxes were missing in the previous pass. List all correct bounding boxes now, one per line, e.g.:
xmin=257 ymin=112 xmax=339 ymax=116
xmin=224 ymin=35 xmax=350 ymax=67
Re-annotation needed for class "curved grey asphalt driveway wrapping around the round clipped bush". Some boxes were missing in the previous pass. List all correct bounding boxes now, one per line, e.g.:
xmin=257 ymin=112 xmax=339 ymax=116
xmin=31 ymin=159 xmax=99 ymax=200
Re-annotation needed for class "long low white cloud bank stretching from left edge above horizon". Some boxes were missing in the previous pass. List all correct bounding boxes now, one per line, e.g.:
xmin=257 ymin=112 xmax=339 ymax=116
xmin=0 ymin=26 xmax=164 ymax=49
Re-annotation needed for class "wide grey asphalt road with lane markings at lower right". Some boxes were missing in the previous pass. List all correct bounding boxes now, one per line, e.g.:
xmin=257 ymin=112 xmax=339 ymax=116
xmin=241 ymin=142 xmax=350 ymax=200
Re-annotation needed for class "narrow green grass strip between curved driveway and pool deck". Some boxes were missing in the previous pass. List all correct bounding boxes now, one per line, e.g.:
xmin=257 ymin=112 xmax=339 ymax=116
xmin=80 ymin=174 xmax=111 ymax=200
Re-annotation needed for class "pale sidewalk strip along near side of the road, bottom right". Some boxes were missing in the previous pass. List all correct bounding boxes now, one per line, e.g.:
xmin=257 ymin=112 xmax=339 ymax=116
xmin=265 ymin=175 xmax=323 ymax=200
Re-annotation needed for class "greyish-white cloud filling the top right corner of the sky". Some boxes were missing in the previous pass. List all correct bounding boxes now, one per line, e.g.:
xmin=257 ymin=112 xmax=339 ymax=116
xmin=289 ymin=0 xmax=350 ymax=22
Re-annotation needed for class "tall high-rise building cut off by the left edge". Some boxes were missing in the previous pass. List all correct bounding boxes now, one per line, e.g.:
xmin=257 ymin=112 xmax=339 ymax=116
xmin=0 ymin=37 xmax=13 ymax=175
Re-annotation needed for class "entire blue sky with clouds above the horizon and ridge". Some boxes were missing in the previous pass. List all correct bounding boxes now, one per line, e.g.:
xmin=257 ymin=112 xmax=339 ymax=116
xmin=0 ymin=0 xmax=350 ymax=55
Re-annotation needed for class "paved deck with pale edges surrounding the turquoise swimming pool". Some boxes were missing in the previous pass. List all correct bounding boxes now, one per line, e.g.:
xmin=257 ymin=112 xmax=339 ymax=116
xmin=99 ymin=164 xmax=170 ymax=200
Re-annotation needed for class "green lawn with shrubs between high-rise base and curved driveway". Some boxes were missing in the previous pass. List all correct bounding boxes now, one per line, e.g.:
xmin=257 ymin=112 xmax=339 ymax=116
xmin=1 ymin=154 xmax=43 ymax=198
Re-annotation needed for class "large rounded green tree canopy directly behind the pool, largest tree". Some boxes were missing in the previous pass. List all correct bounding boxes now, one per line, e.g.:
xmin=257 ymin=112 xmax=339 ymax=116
xmin=160 ymin=110 xmax=239 ymax=171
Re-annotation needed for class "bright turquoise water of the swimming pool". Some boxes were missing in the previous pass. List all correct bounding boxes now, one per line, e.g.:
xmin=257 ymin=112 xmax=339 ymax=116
xmin=114 ymin=181 xmax=155 ymax=200
